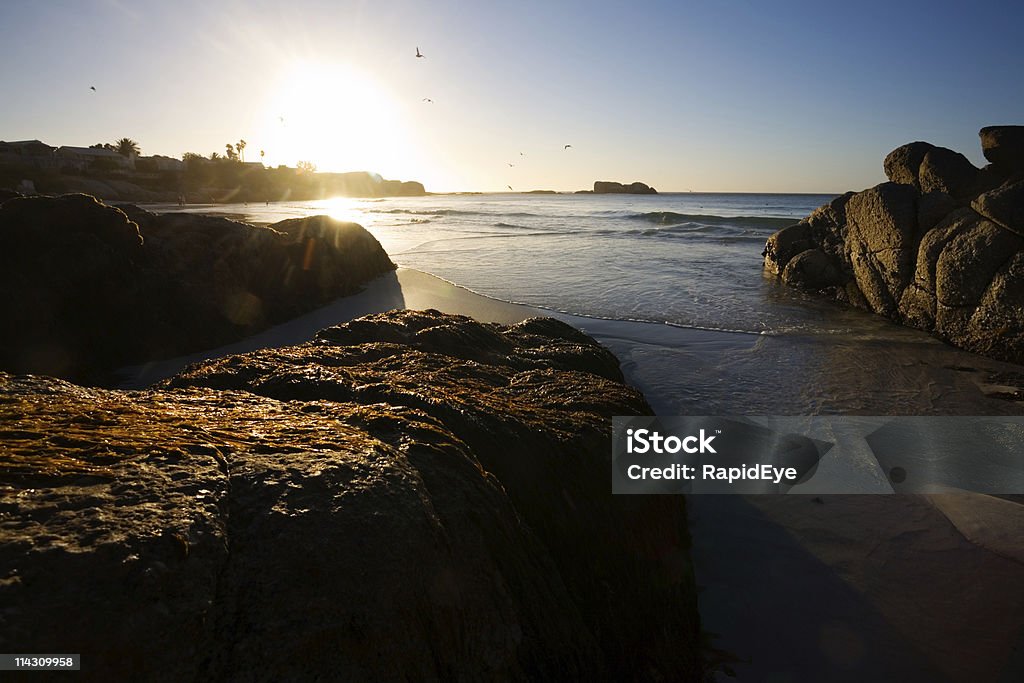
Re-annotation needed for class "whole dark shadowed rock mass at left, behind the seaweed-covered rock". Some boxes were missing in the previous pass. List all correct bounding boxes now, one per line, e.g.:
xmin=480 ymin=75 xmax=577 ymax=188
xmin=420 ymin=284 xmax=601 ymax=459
xmin=0 ymin=195 xmax=394 ymax=382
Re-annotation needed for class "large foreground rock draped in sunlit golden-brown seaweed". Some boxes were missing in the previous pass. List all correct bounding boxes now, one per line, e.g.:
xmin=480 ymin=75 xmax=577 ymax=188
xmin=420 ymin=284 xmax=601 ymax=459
xmin=0 ymin=311 xmax=700 ymax=681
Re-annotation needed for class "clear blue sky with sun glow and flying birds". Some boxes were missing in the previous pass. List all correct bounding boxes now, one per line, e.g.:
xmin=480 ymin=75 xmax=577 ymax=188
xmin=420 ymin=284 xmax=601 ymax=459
xmin=0 ymin=0 xmax=1024 ymax=193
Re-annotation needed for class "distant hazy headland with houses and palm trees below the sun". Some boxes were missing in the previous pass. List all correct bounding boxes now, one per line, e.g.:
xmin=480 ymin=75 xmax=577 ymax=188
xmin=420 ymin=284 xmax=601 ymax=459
xmin=0 ymin=138 xmax=426 ymax=204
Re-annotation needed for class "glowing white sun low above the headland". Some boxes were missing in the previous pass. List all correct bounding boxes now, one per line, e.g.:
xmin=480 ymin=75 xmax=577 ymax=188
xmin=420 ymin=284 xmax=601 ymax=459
xmin=261 ymin=62 xmax=411 ymax=177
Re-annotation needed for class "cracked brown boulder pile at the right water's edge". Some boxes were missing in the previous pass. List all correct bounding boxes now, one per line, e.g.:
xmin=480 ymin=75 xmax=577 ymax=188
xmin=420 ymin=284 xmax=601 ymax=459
xmin=764 ymin=126 xmax=1024 ymax=362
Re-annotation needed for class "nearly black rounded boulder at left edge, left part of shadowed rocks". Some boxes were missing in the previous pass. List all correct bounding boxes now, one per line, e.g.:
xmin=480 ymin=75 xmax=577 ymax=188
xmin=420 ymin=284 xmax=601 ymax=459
xmin=0 ymin=195 xmax=151 ymax=376
